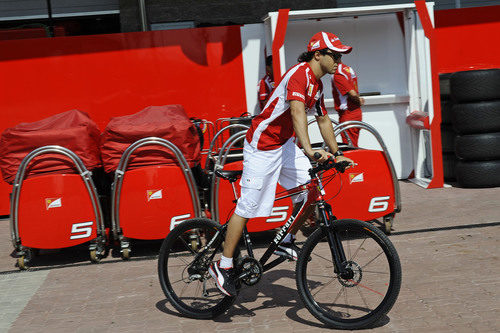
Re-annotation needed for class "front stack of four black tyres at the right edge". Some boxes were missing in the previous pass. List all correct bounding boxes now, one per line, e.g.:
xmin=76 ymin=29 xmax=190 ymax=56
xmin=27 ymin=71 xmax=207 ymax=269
xmin=449 ymin=69 xmax=500 ymax=188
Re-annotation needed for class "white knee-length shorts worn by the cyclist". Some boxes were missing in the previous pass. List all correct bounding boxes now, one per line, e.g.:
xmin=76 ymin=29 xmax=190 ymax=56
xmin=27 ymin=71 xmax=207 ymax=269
xmin=234 ymin=138 xmax=312 ymax=218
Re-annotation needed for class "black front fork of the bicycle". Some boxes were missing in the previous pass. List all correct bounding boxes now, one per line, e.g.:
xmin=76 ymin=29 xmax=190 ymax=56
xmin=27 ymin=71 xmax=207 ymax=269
xmin=318 ymin=201 xmax=350 ymax=277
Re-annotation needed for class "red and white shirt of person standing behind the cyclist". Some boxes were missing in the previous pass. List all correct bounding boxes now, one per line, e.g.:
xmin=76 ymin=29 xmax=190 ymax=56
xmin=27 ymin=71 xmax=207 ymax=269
xmin=332 ymin=63 xmax=361 ymax=112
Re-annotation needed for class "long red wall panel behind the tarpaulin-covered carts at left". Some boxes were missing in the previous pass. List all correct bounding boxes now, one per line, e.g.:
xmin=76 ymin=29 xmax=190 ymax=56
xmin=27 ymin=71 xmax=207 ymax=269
xmin=0 ymin=26 xmax=246 ymax=215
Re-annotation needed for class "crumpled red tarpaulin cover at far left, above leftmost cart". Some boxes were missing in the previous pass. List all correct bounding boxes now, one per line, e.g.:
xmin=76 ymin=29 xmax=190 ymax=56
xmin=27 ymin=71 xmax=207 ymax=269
xmin=0 ymin=110 xmax=101 ymax=184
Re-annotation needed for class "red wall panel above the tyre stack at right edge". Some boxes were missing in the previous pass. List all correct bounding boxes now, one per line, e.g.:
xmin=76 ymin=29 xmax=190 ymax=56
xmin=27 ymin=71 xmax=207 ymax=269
xmin=434 ymin=6 xmax=500 ymax=73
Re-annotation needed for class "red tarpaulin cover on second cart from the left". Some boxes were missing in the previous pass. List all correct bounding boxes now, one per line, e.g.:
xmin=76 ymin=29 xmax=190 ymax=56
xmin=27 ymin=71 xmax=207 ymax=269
xmin=101 ymin=105 xmax=201 ymax=172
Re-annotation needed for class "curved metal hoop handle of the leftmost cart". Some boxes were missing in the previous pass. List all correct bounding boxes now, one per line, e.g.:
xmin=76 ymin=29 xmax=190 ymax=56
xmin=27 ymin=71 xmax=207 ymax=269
xmin=10 ymin=145 xmax=105 ymax=248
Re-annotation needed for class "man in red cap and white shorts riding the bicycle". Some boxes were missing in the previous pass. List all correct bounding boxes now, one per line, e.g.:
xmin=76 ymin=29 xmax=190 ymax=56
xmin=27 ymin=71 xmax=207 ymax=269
xmin=209 ymin=31 xmax=353 ymax=296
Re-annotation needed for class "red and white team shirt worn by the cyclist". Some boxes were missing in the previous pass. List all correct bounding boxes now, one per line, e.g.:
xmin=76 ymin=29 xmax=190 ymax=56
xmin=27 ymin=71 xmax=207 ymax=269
xmin=246 ymin=62 xmax=327 ymax=150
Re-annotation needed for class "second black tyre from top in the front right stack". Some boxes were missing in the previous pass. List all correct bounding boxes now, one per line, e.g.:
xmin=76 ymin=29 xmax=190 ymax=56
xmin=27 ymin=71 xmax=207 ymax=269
xmin=451 ymin=100 xmax=500 ymax=134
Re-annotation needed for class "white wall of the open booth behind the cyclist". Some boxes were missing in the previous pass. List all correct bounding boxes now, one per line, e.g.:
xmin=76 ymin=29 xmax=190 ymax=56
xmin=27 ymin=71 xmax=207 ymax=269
xmin=241 ymin=13 xmax=420 ymax=179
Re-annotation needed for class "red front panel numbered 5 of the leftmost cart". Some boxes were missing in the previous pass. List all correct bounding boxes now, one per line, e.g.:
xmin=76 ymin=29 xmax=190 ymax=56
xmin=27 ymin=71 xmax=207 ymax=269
xmin=18 ymin=174 xmax=97 ymax=249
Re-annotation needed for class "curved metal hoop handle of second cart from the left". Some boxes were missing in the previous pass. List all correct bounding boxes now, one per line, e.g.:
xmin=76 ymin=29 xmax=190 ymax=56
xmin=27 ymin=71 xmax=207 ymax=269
xmin=111 ymin=136 xmax=201 ymax=237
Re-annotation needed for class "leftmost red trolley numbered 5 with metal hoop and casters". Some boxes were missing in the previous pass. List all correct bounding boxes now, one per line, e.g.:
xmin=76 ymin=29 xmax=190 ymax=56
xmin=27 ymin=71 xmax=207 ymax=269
xmin=10 ymin=146 xmax=106 ymax=269
